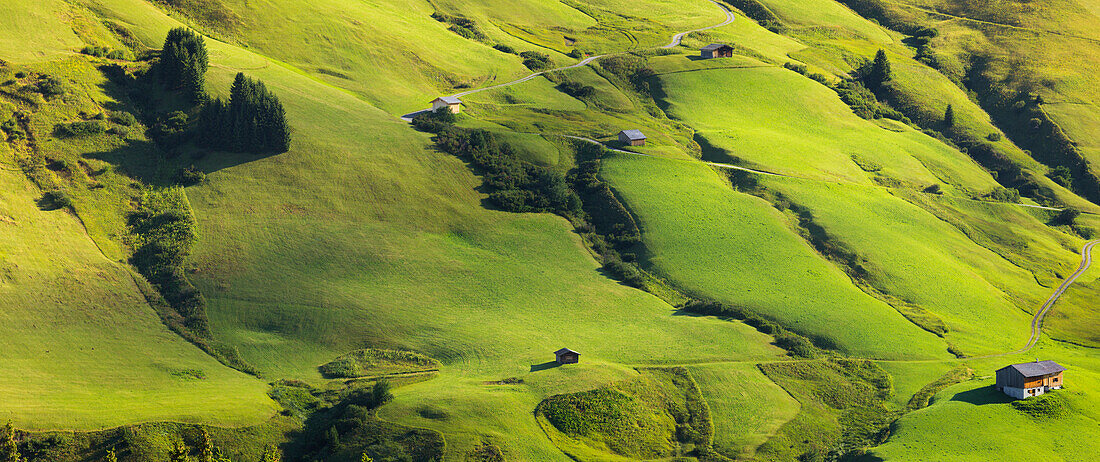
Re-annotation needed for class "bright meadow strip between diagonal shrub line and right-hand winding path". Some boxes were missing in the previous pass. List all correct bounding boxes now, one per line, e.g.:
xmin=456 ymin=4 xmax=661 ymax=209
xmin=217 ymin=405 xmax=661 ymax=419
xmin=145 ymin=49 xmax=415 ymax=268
xmin=763 ymin=178 xmax=1047 ymax=354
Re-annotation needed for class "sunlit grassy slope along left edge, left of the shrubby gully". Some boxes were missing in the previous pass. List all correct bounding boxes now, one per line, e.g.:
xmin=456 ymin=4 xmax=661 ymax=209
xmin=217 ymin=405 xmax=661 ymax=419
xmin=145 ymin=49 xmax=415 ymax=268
xmin=0 ymin=2 xmax=274 ymax=429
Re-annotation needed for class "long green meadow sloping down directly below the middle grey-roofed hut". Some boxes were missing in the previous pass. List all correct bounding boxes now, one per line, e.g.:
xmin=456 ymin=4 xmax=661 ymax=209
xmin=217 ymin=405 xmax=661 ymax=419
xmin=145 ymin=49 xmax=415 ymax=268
xmin=602 ymin=151 xmax=945 ymax=358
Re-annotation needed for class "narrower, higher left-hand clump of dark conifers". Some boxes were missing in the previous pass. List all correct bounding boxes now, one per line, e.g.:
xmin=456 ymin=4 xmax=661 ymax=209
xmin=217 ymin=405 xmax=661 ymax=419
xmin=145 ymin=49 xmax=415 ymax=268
xmin=156 ymin=28 xmax=210 ymax=103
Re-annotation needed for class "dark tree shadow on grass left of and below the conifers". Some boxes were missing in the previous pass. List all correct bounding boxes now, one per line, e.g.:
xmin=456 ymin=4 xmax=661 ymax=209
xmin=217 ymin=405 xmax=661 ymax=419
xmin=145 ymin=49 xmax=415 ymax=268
xmin=86 ymin=64 xmax=275 ymax=186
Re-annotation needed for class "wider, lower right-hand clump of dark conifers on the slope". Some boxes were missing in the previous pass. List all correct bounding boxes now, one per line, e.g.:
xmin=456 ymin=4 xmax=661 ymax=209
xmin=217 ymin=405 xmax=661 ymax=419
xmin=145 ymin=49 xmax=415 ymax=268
xmin=196 ymin=74 xmax=290 ymax=153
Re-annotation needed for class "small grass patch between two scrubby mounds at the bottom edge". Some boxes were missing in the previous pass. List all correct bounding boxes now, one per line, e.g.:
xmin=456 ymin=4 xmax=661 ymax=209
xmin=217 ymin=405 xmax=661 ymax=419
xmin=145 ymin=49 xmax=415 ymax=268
xmin=688 ymin=363 xmax=801 ymax=459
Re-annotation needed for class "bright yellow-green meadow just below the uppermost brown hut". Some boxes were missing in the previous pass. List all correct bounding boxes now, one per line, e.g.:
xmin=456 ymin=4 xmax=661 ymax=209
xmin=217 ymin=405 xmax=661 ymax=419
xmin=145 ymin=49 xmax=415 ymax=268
xmin=660 ymin=64 xmax=996 ymax=191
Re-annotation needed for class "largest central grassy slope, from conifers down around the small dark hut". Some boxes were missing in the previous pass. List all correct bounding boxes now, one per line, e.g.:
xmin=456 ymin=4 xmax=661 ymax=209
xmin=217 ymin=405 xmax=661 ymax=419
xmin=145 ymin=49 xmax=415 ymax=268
xmin=79 ymin=0 xmax=780 ymax=459
